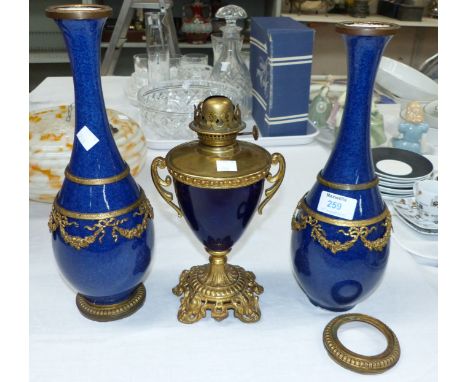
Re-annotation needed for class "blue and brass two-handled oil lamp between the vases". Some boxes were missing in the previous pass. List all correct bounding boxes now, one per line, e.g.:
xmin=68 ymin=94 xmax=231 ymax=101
xmin=151 ymin=96 xmax=285 ymax=324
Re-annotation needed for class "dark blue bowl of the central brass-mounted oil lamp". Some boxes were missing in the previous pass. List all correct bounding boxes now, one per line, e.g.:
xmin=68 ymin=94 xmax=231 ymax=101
xmin=174 ymin=179 xmax=265 ymax=251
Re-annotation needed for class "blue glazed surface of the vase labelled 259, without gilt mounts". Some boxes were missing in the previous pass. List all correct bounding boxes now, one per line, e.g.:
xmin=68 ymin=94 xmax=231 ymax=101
xmin=291 ymin=29 xmax=390 ymax=311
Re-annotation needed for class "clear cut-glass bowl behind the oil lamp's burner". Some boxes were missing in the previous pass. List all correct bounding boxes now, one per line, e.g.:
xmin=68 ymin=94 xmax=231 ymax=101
xmin=138 ymin=80 xmax=242 ymax=140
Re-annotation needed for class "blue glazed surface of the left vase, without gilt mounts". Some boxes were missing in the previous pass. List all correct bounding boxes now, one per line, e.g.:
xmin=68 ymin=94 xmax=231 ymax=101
xmin=52 ymin=15 xmax=154 ymax=304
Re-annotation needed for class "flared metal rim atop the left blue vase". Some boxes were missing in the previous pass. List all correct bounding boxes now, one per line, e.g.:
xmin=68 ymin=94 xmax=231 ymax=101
xmin=45 ymin=4 xmax=112 ymax=20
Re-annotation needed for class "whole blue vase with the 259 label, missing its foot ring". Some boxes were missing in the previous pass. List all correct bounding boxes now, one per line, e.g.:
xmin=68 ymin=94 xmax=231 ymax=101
xmin=291 ymin=22 xmax=398 ymax=311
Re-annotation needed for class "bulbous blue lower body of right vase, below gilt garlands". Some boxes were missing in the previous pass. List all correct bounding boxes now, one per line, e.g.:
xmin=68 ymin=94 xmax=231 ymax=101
xmin=291 ymin=200 xmax=389 ymax=311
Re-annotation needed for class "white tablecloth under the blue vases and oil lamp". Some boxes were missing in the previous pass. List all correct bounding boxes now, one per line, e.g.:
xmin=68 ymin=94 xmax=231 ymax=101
xmin=30 ymin=77 xmax=437 ymax=382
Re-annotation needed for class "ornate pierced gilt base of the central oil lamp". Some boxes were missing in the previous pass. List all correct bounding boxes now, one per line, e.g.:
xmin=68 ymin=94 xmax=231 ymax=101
xmin=172 ymin=259 xmax=263 ymax=324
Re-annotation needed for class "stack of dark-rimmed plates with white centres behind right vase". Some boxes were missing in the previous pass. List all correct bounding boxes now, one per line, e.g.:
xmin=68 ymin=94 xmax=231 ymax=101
xmin=372 ymin=147 xmax=434 ymax=199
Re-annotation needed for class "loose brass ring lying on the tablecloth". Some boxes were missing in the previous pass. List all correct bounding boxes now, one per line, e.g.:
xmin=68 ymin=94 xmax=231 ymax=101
xmin=323 ymin=313 xmax=400 ymax=374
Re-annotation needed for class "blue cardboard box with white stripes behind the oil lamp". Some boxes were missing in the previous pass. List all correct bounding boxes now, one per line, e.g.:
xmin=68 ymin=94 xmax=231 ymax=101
xmin=250 ymin=17 xmax=315 ymax=137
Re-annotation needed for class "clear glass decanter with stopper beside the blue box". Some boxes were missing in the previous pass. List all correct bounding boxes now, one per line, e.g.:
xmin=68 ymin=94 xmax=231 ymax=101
xmin=211 ymin=5 xmax=252 ymax=117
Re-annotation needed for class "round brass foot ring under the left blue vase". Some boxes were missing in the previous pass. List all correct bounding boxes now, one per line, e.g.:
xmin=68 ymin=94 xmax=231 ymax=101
xmin=76 ymin=283 xmax=146 ymax=322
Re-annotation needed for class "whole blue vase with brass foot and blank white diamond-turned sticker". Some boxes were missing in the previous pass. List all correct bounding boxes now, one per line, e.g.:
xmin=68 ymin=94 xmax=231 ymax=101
xmin=46 ymin=5 xmax=154 ymax=321
